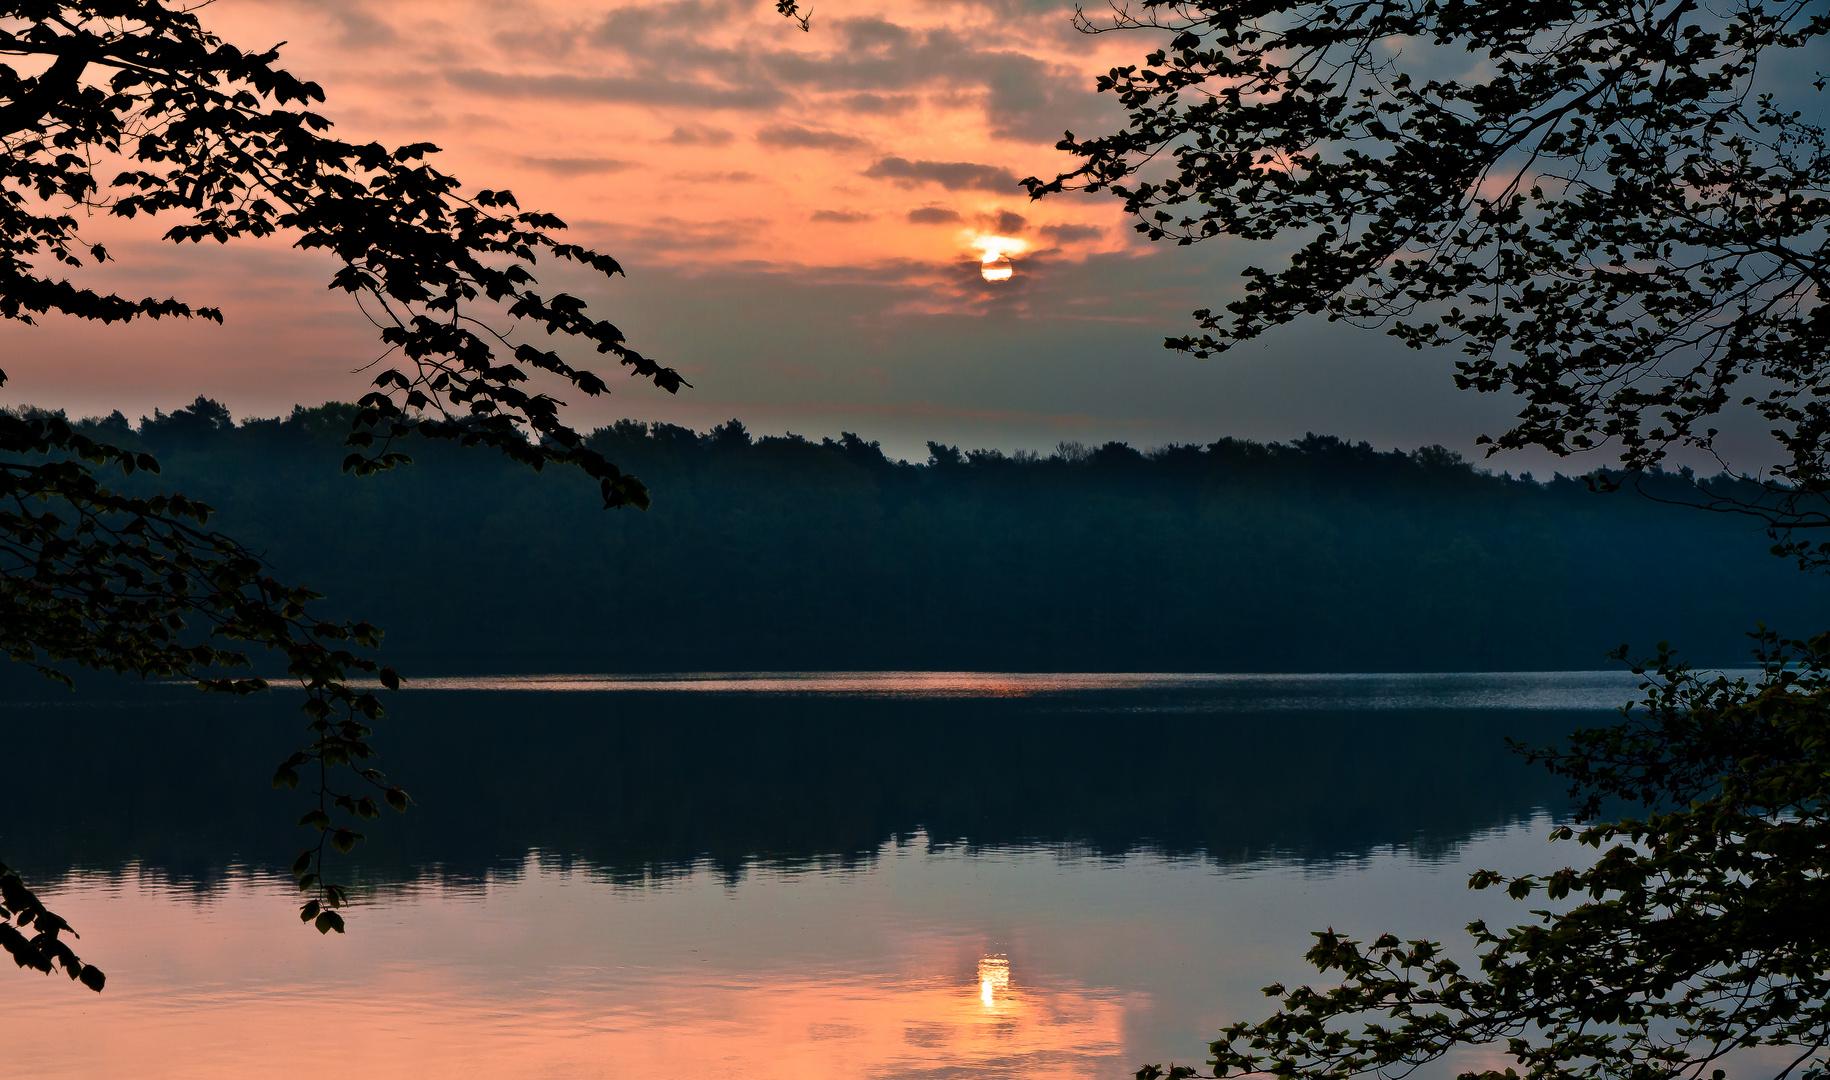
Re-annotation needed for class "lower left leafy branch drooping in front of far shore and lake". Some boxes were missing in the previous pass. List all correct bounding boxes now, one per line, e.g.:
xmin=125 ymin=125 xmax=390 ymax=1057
xmin=0 ymin=395 xmax=408 ymax=988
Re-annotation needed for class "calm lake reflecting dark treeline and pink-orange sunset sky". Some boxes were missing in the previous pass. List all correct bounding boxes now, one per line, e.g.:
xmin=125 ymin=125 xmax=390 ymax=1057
xmin=0 ymin=672 xmax=1636 ymax=1080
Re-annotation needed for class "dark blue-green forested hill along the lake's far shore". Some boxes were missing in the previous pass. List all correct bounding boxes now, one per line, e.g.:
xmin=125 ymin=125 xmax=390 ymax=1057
xmin=25 ymin=399 xmax=1830 ymax=674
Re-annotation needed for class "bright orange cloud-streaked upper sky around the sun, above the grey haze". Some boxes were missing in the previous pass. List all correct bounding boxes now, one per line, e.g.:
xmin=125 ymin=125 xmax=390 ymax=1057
xmin=189 ymin=0 xmax=1138 ymax=294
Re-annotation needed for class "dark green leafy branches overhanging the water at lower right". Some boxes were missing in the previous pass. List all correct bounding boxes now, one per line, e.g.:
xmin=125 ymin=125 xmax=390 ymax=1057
xmin=1138 ymin=633 xmax=1830 ymax=1080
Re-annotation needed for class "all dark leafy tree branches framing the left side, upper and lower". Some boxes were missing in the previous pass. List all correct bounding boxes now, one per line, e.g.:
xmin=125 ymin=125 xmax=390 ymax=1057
xmin=0 ymin=0 xmax=684 ymax=990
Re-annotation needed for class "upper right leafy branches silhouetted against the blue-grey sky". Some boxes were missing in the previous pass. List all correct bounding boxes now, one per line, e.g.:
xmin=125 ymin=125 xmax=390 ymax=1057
xmin=1025 ymin=0 xmax=1830 ymax=564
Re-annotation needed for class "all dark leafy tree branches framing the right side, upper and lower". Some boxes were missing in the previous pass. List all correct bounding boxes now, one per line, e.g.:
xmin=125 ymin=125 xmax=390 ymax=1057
xmin=936 ymin=0 xmax=1830 ymax=1080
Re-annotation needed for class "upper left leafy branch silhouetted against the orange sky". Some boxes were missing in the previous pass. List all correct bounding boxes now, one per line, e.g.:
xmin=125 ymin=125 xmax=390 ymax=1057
xmin=0 ymin=0 xmax=686 ymax=507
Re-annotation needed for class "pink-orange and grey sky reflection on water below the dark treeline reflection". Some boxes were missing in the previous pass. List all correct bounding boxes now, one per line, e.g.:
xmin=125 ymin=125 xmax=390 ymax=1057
xmin=0 ymin=820 xmax=1565 ymax=1080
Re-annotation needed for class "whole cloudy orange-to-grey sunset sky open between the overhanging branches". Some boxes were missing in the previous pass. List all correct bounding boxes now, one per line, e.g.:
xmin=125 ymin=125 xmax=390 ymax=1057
xmin=0 ymin=0 xmax=1712 ymax=470
